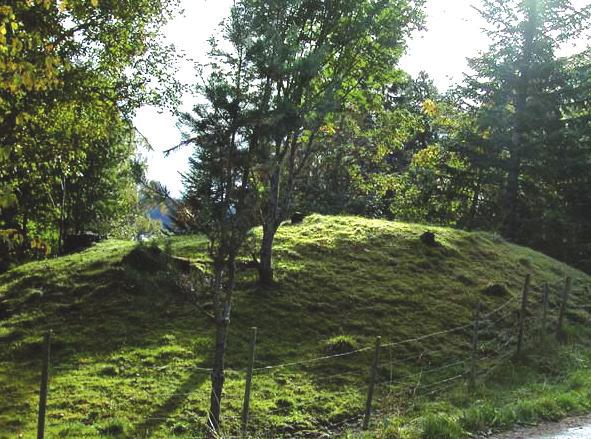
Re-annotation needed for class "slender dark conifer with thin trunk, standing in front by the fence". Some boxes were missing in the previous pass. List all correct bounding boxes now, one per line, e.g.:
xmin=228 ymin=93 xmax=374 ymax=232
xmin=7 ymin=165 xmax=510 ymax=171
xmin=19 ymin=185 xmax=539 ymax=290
xmin=180 ymin=8 xmax=257 ymax=437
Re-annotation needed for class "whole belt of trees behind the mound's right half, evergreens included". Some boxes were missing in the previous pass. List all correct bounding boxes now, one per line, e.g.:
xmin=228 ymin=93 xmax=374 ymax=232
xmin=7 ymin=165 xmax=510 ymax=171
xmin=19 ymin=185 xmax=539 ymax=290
xmin=295 ymin=0 xmax=591 ymax=276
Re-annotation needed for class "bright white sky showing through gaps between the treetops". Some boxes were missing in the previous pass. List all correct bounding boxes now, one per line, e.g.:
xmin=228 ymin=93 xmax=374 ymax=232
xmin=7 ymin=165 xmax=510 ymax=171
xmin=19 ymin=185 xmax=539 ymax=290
xmin=134 ymin=0 xmax=591 ymax=196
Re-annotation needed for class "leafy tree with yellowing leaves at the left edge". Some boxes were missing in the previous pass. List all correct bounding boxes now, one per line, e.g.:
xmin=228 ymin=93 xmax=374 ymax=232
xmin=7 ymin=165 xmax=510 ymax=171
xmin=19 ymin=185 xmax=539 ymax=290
xmin=0 ymin=0 xmax=176 ymax=256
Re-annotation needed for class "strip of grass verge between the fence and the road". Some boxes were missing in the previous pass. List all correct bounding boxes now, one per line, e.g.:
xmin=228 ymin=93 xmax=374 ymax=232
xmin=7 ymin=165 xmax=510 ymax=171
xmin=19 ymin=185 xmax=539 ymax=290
xmin=347 ymin=343 xmax=591 ymax=439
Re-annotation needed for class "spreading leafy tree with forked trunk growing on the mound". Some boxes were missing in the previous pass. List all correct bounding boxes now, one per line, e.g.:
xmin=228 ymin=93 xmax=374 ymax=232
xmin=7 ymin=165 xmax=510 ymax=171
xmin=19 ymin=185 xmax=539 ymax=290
xmin=228 ymin=0 xmax=422 ymax=284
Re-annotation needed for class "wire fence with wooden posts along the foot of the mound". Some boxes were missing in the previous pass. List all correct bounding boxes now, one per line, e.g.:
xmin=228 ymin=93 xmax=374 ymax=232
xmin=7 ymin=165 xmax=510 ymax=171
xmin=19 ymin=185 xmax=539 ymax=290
xmin=28 ymin=276 xmax=591 ymax=437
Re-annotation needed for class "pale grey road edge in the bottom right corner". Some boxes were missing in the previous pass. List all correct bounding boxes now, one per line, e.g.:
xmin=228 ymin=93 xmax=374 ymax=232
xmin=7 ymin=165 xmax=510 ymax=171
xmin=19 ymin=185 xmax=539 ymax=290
xmin=480 ymin=415 xmax=591 ymax=439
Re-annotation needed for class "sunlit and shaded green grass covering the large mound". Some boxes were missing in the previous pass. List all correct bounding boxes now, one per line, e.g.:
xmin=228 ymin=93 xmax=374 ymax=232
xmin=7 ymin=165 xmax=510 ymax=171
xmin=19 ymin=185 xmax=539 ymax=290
xmin=0 ymin=215 xmax=591 ymax=439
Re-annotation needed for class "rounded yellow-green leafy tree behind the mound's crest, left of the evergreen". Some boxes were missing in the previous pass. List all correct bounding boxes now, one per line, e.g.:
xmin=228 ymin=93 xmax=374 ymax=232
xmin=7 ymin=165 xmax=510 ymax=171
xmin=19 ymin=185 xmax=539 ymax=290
xmin=297 ymin=72 xmax=468 ymax=223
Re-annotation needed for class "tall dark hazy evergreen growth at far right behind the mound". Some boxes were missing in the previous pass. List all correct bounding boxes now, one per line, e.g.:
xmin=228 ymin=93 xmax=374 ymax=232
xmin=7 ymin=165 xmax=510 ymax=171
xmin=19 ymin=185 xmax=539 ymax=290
xmin=457 ymin=0 xmax=591 ymax=262
